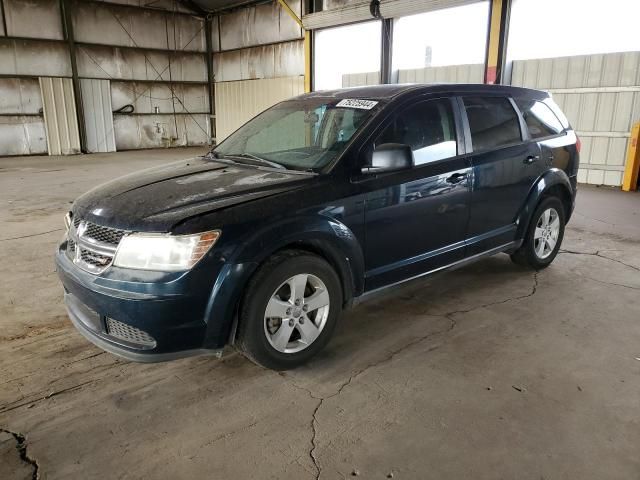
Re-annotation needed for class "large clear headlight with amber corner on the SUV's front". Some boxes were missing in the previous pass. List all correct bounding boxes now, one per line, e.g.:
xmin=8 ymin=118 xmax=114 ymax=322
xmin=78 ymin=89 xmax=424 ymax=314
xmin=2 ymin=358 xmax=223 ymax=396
xmin=113 ymin=231 xmax=220 ymax=272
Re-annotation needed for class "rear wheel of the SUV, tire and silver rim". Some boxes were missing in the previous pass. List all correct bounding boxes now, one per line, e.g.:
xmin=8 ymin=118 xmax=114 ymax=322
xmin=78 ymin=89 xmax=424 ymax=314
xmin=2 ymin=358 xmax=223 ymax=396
xmin=511 ymin=197 xmax=565 ymax=270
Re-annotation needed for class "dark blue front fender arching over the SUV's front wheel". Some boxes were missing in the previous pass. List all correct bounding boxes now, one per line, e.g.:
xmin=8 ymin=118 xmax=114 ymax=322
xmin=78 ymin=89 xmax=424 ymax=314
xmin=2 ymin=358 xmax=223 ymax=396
xmin=200 ymin=214 xmax=364 ymax=348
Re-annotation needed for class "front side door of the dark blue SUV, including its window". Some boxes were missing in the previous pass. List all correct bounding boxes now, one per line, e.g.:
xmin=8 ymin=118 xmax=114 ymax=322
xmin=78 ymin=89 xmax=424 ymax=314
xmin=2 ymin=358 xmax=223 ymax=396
xmin=363 ymin=98 xmax=471 ymax=291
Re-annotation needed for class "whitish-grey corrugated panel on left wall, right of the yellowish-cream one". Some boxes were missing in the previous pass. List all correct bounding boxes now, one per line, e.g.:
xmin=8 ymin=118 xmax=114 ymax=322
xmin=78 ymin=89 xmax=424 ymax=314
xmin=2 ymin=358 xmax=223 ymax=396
xmin=80 ymin=78 xmax=116 ymax=153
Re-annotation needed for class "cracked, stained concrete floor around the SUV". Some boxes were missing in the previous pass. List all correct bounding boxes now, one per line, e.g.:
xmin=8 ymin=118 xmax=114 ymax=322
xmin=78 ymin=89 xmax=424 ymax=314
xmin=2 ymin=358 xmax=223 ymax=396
xmin=0 ymin=149 xmax=640 ymax=480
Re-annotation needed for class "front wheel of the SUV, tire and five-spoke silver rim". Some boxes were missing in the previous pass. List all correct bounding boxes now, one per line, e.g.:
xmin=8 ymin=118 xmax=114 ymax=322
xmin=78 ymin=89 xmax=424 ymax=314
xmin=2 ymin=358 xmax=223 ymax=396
xmin=236 ymin=250 xmax=342 ymax=370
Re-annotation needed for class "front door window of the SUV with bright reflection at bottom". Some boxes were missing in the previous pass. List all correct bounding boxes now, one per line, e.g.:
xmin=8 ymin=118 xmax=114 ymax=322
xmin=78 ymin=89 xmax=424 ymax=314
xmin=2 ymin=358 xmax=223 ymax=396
xmin=376 ymin=100 xmax=458 ymax=165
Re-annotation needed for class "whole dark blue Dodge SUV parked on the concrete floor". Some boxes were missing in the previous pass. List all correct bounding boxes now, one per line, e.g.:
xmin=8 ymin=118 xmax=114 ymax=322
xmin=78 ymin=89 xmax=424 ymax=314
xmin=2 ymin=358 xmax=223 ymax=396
xmin=56 ymin=85 xmax=580 ymax=369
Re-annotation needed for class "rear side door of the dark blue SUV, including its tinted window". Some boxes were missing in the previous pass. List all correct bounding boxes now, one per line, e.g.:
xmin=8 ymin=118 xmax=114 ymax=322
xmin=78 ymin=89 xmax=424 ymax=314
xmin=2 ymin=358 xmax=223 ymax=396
xmin=461 ymin=95 xmax=541 ymax=256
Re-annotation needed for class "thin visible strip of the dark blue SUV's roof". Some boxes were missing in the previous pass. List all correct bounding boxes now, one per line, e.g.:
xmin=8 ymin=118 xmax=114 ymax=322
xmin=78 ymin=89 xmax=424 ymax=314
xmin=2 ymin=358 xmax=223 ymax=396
xmin=296 ymin=83 xmax=549 ymax=100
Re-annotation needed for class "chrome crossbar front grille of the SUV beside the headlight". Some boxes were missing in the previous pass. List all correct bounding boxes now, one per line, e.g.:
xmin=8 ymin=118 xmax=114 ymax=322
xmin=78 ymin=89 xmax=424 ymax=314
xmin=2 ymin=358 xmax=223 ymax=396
xmin=67 ymin=218 xmax=128 ymax=274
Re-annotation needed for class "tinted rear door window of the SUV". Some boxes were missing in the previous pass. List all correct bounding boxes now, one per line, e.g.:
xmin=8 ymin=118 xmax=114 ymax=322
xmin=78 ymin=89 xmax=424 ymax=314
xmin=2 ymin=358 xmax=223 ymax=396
xmin=464 ymin=97 xmax=522 ymax=151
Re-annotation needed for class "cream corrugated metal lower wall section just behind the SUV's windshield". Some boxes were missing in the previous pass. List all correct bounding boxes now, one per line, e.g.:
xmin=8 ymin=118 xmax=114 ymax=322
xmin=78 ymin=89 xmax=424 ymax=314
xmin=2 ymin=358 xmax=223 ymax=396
xmin=215 ymin=76 xmax=304 ymax=142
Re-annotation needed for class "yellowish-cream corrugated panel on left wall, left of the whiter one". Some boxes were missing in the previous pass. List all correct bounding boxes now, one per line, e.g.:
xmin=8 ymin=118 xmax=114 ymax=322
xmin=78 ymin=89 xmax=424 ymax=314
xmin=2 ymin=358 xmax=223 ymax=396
xmin=40 ymin=77 xmax=80 ymax=155
